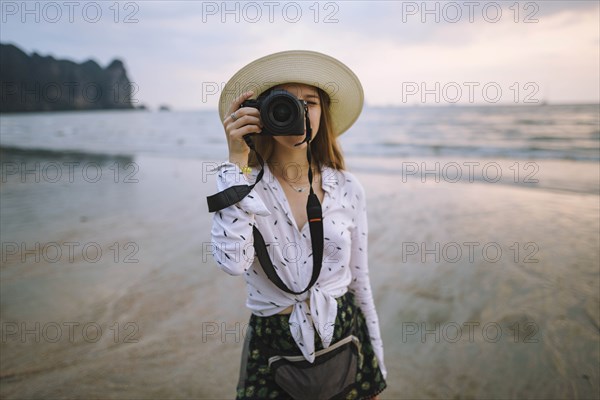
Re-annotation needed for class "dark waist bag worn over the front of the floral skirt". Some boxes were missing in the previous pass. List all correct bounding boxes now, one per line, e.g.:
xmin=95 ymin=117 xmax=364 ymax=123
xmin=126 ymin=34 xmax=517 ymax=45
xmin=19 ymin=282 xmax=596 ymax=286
xmin=269 ymin=335 xmax=362 ymax=400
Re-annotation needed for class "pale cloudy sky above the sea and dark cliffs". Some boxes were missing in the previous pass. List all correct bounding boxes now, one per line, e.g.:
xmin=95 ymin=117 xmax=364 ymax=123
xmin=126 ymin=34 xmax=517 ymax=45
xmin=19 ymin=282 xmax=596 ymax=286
xmin=0 ymin=0 xmax=600 ymax=109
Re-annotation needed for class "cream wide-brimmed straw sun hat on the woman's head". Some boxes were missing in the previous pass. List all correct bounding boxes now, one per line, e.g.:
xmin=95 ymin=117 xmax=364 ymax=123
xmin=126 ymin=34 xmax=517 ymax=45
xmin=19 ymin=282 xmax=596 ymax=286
xmin=219 ymin=50 xmax=364 ymax=136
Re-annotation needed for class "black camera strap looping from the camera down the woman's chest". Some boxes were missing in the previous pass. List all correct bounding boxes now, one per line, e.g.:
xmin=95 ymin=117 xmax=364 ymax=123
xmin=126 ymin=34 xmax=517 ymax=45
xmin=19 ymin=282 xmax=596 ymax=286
xmin=207 ymin=104 xmax=323 ymax=295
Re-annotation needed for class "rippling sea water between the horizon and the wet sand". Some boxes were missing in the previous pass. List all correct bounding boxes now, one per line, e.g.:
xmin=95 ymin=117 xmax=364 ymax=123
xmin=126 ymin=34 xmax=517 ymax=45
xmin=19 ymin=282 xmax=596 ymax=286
xmin=0 ymin=104 xmax=600 ymax=162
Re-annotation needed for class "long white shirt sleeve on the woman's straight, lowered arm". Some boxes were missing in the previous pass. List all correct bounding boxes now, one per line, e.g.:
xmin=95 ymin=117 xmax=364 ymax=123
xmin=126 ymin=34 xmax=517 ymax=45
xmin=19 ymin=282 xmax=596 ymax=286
xmin=349 ymin=178 xmax=387 ymax=379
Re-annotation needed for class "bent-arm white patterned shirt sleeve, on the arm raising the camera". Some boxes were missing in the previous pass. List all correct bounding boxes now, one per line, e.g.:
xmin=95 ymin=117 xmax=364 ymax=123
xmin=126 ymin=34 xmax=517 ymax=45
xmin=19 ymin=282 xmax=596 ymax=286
xmin=211 ymin=162 xmax=271 ymax=275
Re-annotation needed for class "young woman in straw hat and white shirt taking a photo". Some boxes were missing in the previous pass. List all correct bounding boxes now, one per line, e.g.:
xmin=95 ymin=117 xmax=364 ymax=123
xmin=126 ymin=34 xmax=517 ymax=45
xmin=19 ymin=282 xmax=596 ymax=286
xmin=212 ymin=51 xmax=387 ymax=399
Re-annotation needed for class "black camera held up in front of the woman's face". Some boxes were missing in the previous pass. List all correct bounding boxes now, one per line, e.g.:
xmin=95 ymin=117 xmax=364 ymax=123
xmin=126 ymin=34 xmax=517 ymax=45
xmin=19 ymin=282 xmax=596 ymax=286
xmin=240 ymin=89 xmax=306 ymax=136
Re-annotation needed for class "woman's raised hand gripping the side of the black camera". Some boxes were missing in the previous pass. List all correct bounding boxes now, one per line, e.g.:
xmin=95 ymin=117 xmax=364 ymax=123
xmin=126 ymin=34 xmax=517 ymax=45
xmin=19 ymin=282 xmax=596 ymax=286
xmin=223 ymin=92 xmax=262 ymax=167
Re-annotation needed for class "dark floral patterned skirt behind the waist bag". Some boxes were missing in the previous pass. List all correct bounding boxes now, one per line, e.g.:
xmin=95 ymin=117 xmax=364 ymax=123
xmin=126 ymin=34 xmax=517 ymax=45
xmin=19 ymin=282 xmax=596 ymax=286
xmin=236 ymin=292 xmax=387 ymax=399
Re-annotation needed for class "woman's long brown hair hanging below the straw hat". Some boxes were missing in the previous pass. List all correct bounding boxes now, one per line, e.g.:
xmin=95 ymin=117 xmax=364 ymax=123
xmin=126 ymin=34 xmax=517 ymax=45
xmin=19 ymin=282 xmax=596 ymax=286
xmin=248 ymin=88 xmax=346 ymax=171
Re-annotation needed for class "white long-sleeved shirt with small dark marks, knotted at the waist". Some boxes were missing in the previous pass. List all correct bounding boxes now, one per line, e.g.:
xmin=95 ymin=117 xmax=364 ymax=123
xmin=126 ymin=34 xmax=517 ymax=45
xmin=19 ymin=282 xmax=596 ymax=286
xmin=211 ymin=162 xmax=387 ymax=378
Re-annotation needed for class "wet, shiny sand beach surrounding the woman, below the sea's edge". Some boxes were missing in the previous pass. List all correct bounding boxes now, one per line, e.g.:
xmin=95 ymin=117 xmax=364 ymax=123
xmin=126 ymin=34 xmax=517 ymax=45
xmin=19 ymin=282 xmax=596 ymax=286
xmin=0 ymin=153 xmax=600 ymax=399
